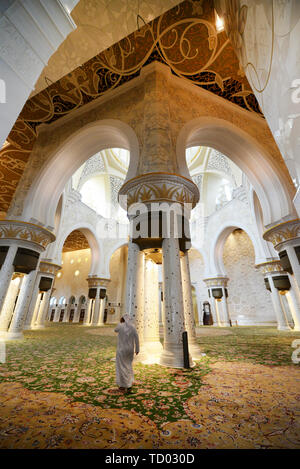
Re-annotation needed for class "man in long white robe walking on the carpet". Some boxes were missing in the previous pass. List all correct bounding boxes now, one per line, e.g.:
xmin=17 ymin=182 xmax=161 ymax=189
xmin=115 ymin=313 xmax=140 ymax=392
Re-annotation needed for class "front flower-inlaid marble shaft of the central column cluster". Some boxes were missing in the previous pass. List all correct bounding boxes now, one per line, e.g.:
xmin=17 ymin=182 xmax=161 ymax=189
xmin=160 ymin=238 xmax=193 ymax=368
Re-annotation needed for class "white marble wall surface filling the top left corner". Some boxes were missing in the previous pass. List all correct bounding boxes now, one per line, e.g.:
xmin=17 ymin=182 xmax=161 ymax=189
xmin=0 ymin=0 xmax=76 ymax=148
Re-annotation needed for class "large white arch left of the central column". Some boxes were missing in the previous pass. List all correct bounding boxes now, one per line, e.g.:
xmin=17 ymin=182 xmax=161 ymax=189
xmin=9 ymin=119 xmax=139 ymax=229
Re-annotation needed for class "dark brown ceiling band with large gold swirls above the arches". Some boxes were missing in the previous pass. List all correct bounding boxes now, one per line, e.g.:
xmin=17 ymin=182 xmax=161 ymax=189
xmin=0 ymin=0 xmax=260 ymax=212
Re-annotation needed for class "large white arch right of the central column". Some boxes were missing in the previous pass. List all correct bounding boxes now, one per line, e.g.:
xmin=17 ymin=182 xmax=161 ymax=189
xmin=177 ymin=116 xmax=295 ymax=226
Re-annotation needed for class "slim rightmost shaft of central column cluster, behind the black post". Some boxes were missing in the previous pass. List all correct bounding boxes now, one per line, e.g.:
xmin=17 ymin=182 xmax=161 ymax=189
xmin=180 ymin=252 xmax=202 ymax=360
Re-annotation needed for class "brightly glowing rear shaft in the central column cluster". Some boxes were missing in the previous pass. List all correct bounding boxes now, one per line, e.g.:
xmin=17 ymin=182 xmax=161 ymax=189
xmin=143 ymin=259 xmax=163 ymax=362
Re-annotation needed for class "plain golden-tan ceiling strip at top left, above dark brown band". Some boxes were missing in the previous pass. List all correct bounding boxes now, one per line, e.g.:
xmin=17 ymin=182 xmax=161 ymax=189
xmin=32 ymin=0 xmax=181 ymax=95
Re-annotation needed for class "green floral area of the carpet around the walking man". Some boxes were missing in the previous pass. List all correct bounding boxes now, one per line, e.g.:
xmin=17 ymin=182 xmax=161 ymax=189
xmin=0 ymin=324 xmax=209 ymax=424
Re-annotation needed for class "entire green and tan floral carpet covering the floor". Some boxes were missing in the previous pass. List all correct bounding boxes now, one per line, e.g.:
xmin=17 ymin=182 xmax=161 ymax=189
xmin=0 ymin=324 xmax=300 ymax=449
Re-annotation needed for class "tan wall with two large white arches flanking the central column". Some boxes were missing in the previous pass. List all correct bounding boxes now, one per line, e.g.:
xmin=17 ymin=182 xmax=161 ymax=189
xmin=8 ymin=64 xmax=295 ymax=233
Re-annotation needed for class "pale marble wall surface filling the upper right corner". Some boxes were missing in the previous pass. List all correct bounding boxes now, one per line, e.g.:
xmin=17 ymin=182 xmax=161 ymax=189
xmin=215 ymin=0 xmax=300 ymax=207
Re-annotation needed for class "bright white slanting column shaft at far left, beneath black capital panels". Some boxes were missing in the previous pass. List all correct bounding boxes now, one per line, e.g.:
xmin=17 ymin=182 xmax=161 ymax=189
xmin=7 ymin=270 xmax=37 ymax=340
